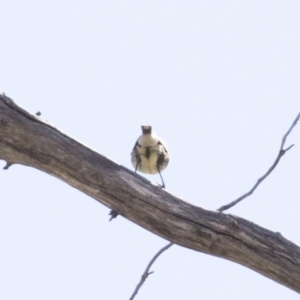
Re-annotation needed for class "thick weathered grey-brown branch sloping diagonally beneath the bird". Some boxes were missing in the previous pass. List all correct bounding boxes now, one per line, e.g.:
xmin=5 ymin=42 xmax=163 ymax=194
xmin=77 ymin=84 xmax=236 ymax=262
xmin=0 ymin=94 xmax=300 ymax=293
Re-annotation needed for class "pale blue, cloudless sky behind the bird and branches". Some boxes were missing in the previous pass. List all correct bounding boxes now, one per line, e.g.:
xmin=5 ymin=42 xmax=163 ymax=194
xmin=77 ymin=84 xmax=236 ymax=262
xmin=0 ymin=0 xmax=300 ymax=300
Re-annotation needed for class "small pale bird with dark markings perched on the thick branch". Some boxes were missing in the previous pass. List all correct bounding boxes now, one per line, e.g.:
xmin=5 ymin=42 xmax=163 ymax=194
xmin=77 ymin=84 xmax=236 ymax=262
xmin=131 ymin=125 xmax=170 ymax=188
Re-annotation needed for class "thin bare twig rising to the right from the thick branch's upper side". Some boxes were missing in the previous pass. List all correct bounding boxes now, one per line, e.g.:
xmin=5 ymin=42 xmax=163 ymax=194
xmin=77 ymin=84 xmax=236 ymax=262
xmin=218 ymin=113 xmax=300 ymax=212
